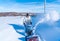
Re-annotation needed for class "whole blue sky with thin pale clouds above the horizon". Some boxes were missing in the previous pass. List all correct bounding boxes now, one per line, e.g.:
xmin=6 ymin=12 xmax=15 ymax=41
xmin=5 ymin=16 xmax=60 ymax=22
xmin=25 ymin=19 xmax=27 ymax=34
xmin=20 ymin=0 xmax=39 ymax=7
xmin=0 ymin=0 xmax=60 ymax=13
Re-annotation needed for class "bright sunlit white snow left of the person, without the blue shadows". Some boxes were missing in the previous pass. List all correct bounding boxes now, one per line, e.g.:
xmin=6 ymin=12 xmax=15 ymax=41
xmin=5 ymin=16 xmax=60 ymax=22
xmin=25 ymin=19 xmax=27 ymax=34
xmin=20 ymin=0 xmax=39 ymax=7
xmin=0 ymin=16 xmax=41 ymax=41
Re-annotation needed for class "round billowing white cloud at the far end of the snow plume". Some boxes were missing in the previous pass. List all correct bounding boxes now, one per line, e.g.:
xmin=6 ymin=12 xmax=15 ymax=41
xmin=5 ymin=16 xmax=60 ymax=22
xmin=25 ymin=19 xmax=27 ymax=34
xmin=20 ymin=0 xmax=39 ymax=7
xmin=46 ymin=10 xmax=60 ymax=22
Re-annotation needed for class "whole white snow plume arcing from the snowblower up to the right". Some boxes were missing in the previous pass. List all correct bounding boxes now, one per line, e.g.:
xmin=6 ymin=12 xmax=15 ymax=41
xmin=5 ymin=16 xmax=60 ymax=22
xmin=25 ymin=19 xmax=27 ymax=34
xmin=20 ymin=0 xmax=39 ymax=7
xmin=33 ymin=10 xmax=60 ymax=32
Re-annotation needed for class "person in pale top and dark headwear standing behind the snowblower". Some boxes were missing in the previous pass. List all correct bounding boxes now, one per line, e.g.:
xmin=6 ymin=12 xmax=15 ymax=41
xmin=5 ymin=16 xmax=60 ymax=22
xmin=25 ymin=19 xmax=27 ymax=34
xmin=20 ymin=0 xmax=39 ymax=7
xmin=23 ymin=13 xmax=32 ymax=36
